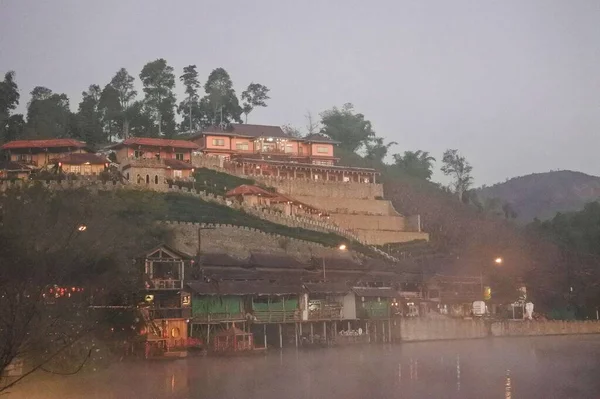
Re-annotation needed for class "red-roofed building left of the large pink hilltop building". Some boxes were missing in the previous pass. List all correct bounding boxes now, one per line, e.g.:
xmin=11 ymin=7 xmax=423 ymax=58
xmin=111 ymin=137 xmax=199 ymax=164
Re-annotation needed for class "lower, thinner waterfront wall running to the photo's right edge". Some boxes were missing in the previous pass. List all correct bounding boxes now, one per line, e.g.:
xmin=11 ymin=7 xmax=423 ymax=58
xmin=491 ymin=320 xmax=600 ymax=337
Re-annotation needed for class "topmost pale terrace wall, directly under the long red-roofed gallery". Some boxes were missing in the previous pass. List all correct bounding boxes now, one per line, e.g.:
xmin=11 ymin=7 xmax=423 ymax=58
xmin=253 ymin=176 xmax=383 ymax=199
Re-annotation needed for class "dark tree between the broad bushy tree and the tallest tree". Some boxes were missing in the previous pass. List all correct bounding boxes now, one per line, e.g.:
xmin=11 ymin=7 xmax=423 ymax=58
xmin=74 ymin=85 xmax=105 ymax=144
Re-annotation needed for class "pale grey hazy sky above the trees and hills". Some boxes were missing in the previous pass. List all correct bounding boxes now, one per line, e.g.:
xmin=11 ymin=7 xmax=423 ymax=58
xmin=0 ymin=0 xmax=600 ymax=185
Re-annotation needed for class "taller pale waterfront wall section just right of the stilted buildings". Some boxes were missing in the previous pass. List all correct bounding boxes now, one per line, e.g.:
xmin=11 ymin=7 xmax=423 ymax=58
xmin=392 ymin=318 xmax=488 ymax=341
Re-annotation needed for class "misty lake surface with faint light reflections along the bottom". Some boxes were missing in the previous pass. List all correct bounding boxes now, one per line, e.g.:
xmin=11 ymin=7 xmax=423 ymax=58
xmin=9 ymin=336 xmax=600 ymax=399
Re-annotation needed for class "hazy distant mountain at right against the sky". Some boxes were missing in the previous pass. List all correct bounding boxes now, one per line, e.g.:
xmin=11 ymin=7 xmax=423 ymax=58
xmin=476 ymin=170 xmax=600 ymax=223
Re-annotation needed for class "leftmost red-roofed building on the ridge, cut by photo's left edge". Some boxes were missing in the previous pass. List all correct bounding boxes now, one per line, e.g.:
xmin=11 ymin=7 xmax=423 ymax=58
xmin=0 ymin=139 xmax=92 ymax=167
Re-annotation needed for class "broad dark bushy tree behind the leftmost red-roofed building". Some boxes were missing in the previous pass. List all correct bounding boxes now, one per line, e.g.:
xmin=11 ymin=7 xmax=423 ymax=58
xmin=27 ymin=86 xmax=71 ymax=138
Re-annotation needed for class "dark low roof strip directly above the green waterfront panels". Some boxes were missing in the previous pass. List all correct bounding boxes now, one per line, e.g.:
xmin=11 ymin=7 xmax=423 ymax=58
xmin=187 ymin=281 xmax=302 ymax=295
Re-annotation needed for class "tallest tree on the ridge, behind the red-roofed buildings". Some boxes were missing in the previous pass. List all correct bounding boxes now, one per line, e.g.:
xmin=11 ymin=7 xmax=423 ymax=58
xmin=140 ymin=58 xmax=175 ymax=136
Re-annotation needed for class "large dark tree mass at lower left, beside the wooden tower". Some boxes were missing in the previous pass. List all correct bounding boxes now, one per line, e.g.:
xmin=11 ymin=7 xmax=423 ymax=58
xmin=0 ymin=186 xmax=165 ymax=392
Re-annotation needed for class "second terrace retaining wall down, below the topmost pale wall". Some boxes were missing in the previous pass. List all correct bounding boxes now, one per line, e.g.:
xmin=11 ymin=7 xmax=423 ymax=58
xmin=291 ymin=196 xmax=399 ymax=216
